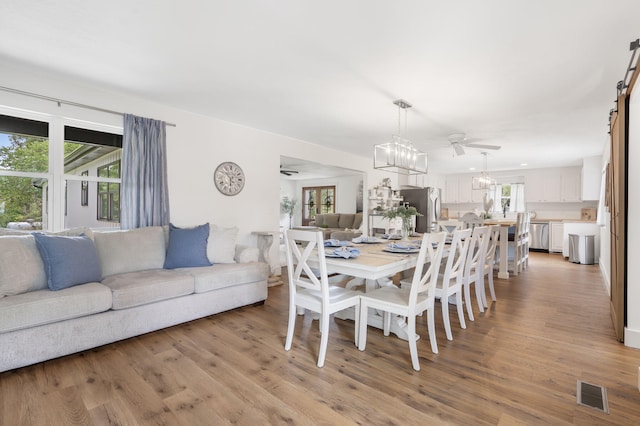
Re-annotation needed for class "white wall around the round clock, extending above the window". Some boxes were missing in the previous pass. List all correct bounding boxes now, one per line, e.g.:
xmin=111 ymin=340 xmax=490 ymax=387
xmin=0 ymin=60 xmax=372 ymax=270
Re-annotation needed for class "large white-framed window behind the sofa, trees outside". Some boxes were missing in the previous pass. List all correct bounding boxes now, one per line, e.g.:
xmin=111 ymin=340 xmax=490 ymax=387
xmin=0 ymin=110 xmax=122 ymax=231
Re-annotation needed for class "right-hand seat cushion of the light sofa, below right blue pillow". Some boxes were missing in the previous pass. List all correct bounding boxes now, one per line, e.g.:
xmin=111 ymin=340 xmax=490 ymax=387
xmin=179 ymin=262 xmax=269 ymax=293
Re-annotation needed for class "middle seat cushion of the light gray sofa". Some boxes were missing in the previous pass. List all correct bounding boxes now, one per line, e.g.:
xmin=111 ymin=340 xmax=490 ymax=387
xmin=102 ymin=269 xmax=194 ymax=309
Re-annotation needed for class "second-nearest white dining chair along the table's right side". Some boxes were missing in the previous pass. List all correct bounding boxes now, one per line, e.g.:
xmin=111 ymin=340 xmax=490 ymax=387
xmin=435 ymin=229 xmax=472 ymax=340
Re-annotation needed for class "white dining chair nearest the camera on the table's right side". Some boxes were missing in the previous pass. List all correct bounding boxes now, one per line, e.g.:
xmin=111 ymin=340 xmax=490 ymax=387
xmin=358 ymin=232 xmax=447 ymax=371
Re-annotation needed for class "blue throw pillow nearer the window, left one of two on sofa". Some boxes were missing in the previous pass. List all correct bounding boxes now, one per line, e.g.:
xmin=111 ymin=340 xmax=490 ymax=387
xmin=33 ymin=233 xmax=102 ymax=290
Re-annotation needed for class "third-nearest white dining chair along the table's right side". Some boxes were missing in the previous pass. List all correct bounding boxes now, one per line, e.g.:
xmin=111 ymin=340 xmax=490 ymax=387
xmin=462 ymin=226 xmax=489 ymax=321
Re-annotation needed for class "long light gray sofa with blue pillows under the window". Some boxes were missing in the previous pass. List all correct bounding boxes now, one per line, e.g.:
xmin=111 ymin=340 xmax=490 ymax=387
xmin=0 ymin=224 xmax=269 ymax=371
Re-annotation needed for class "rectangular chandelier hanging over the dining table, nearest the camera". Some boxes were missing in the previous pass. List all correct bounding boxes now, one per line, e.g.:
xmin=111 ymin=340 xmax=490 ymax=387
xmin=373 ymin=99 xmax=427 ymax=175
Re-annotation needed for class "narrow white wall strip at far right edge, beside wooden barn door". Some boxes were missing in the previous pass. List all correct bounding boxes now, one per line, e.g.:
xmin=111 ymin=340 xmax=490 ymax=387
xmin=624 ymin=88 xmax=640 ymax=348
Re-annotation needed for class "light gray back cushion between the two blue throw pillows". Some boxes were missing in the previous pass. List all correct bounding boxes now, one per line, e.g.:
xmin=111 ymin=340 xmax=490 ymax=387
xmin=93 ymin=226 xmax=166 ymax=277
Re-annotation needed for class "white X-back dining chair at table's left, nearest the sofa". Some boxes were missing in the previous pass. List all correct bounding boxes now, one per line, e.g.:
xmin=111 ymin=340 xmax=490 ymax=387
xmin=284 ymin=229 xmax=360 ymax=367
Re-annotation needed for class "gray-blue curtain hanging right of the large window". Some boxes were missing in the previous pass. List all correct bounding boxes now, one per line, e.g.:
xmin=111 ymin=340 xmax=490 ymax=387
xmin=120 ymin=114 xmax=169 ymax=229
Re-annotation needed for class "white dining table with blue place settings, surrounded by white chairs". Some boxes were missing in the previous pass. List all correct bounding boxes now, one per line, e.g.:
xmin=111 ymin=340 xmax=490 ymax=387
xmin=318 ymin=237 xmax=440 ymax=340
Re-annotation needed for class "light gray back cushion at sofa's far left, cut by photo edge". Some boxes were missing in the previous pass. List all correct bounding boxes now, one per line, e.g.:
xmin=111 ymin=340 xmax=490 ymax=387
xmin=0 ymin=235 xmax=47 ymax=300
